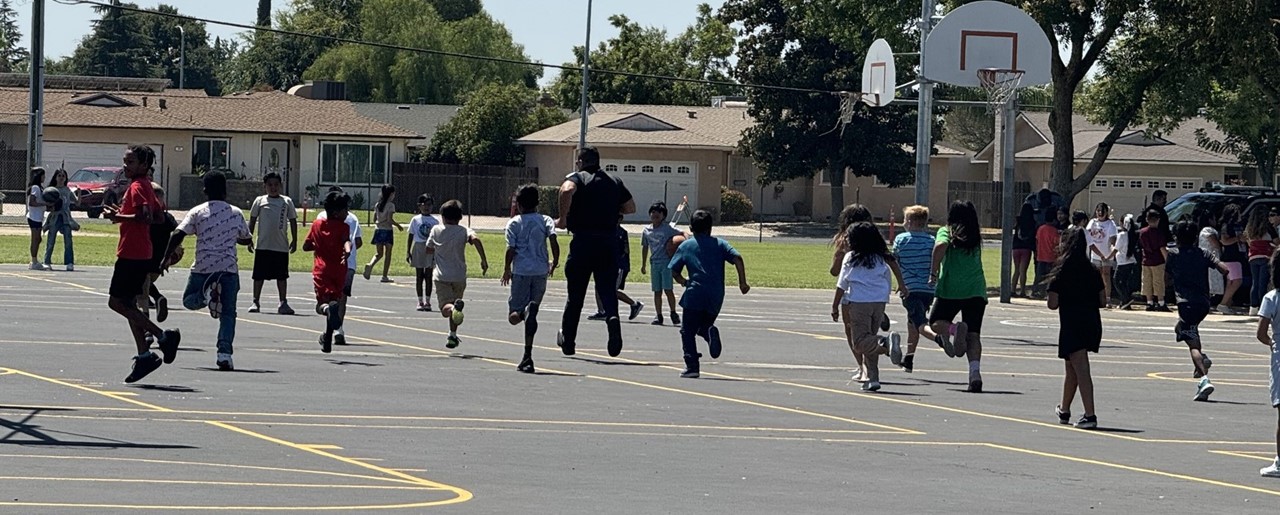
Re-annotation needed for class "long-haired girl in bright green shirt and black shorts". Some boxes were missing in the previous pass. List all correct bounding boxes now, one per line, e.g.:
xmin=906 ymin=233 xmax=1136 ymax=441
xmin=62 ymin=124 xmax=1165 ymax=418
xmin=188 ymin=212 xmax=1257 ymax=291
xmin=929 ymin=200 xmax=987 ymax=393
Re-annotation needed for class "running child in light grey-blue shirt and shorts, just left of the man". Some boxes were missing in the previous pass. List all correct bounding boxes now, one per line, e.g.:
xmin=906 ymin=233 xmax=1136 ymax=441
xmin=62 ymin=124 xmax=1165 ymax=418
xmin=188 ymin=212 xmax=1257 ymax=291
xmin=501 ymin=184 xmax=559 ymax=374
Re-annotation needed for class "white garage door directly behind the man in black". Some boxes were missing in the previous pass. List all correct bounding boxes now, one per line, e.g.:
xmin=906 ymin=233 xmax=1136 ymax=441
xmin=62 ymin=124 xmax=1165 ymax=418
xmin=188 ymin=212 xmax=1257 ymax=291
xmin=600 ymin=160 xmax=698 ymax=224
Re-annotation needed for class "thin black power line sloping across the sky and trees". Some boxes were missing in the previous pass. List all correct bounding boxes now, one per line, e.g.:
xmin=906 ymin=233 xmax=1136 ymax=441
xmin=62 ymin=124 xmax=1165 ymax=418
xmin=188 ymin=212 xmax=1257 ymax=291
xmin=54 ymin=0 xmax=838 ymax=95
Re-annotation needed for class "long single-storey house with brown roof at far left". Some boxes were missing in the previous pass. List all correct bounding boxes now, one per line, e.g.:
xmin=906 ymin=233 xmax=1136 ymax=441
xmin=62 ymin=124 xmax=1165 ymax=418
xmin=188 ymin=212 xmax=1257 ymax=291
xmin=0 ymin=74 xmax=421 ymax=206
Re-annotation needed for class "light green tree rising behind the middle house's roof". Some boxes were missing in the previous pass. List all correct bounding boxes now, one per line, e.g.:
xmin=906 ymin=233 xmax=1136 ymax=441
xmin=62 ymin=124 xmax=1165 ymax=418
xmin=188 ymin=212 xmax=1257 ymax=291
xmin=548 ymin=4 xmax=736 ymax=105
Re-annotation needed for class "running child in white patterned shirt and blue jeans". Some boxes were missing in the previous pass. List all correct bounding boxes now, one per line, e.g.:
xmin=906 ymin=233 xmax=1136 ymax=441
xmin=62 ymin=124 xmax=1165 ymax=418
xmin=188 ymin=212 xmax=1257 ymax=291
xmin=165 ymin=172 xmax=253 ymax=370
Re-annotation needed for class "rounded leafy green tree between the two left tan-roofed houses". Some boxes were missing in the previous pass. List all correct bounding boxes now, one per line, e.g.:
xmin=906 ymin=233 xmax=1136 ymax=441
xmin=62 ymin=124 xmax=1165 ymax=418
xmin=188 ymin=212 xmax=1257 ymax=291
xmin=422 ymin=85 xmax=568 ymax=165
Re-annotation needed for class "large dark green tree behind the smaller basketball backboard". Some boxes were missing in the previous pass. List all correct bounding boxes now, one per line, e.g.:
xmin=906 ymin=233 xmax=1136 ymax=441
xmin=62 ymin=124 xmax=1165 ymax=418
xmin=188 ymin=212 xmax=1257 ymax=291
xmin=719 ymin=0 xmax=918 ymax=213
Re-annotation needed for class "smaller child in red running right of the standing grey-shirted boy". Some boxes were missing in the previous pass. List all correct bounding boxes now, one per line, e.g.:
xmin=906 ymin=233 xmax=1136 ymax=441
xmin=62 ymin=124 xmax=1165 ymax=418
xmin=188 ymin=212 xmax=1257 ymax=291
xmin=302 ymin=191 xmax=351 ymax=352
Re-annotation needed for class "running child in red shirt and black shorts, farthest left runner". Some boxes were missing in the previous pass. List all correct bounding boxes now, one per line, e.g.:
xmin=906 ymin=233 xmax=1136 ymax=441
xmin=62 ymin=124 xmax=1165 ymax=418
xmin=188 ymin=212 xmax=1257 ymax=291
xmin=102 ymin=145 xmax=182 ymax=383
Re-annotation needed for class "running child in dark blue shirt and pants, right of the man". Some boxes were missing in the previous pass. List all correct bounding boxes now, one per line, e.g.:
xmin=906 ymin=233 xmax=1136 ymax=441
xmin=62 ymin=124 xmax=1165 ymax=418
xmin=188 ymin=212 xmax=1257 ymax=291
xmin=659 ymin=209 xmax=751 ymax=378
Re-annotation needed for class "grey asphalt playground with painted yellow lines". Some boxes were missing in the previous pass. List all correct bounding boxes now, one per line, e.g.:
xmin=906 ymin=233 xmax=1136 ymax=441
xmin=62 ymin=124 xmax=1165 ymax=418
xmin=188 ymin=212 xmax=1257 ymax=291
xmin=0 ymin=265 xmax=1280 ymax=514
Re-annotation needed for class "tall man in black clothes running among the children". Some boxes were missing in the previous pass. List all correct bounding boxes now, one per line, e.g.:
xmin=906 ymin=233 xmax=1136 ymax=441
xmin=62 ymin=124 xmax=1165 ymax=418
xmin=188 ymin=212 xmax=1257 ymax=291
xmin=556 ymin=147 xmax=636 ymax=356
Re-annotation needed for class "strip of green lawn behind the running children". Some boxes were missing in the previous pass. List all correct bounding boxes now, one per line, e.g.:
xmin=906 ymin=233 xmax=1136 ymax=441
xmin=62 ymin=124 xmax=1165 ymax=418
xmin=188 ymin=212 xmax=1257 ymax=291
xmin=0 ymin=224 xmax=1000 ymax=290
